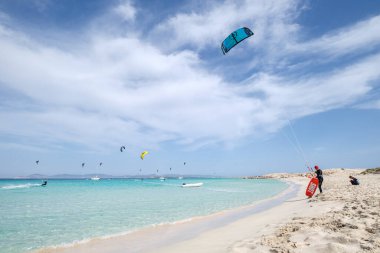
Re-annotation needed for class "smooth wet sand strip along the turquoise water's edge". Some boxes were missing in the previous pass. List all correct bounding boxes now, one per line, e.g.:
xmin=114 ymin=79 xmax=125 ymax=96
xmin=32 ymin=179 xmax=300 ymax=253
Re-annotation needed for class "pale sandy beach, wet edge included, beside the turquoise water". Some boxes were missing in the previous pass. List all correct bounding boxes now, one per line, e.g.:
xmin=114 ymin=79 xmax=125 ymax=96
xmin=38 ymin=169 xmax=380 ymax=253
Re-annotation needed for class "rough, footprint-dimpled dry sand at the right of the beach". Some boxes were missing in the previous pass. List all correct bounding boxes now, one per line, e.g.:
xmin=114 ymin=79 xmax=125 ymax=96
xmin=234 ymin=170 xmax=380 ymax=253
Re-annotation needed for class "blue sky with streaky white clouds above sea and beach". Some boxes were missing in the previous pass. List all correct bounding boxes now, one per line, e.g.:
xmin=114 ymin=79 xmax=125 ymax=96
xmin=0 ymin=0 xmax=380 ymax=177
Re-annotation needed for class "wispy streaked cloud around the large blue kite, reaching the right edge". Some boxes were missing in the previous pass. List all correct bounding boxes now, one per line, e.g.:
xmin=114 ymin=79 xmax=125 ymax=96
xmin=152 ymin=0 xmax=380 ymax=73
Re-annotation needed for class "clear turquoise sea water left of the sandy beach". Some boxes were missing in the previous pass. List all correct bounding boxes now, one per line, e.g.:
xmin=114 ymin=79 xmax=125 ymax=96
xmin=0 ymin=178 xmax=287 ymax=252
